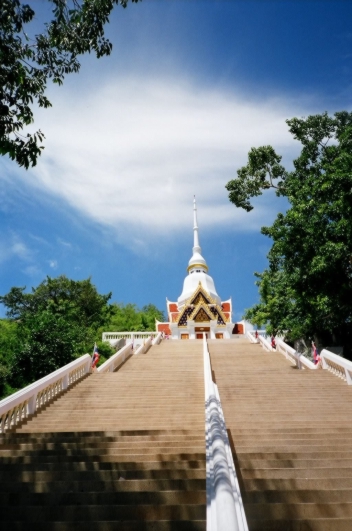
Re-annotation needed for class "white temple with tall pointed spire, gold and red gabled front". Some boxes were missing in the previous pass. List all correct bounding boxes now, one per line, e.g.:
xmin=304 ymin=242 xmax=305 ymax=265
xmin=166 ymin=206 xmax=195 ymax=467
xmin=156 ymin=198 xmax=244 ymax=339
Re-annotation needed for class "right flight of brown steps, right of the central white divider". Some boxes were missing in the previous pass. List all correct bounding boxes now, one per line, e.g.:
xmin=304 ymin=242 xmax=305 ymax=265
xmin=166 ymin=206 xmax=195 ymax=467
xmin=208 ymin=338 xmax=352 ymax=531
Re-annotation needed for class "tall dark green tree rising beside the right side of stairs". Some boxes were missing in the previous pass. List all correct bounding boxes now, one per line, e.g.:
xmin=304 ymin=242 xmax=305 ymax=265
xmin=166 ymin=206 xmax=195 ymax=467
xmin=226 ymin=112 xmax=352 ymax=357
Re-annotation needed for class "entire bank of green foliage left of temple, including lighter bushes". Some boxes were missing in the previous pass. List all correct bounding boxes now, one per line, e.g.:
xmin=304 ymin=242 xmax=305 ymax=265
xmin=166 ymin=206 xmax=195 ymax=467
xmin=0 ymin=275 xmax=164 ymax=396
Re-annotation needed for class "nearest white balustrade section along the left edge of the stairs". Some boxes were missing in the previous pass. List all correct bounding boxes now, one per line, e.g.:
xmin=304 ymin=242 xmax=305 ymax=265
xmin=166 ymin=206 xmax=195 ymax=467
xmin=0 ymin=354 xmax=92 ymax=433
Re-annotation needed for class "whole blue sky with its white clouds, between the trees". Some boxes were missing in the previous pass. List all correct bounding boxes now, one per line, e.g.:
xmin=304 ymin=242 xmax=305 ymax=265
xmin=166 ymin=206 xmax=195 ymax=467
xmin=0 ymin=0 xmax=352 ymax=319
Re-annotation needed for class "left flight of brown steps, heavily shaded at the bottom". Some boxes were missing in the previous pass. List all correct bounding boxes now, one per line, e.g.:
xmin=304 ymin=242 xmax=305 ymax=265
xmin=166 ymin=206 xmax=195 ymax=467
xmin=0 ymin=341 xmax=206 ymax=531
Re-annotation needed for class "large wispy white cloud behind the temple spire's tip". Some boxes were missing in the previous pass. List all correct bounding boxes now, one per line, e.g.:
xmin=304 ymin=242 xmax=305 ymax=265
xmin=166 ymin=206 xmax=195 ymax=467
xmin=21 ymin=77 xmax=306 ymax=247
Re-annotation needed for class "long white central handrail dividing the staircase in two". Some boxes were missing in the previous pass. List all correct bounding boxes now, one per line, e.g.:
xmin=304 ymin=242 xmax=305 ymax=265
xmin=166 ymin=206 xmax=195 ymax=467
xmin=203 ymin=334 xmax=248 ymax=531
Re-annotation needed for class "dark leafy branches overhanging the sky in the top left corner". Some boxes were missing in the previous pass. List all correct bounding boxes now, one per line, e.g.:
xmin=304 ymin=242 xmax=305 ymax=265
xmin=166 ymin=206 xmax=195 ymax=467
xmin=0 ymin=0 xmax=138 ymax=168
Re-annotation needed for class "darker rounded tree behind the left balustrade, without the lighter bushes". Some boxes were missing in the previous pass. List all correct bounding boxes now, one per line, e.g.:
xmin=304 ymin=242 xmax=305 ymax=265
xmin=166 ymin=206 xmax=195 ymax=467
xmin=0 ymin=276 xmax=111 ymax=387
